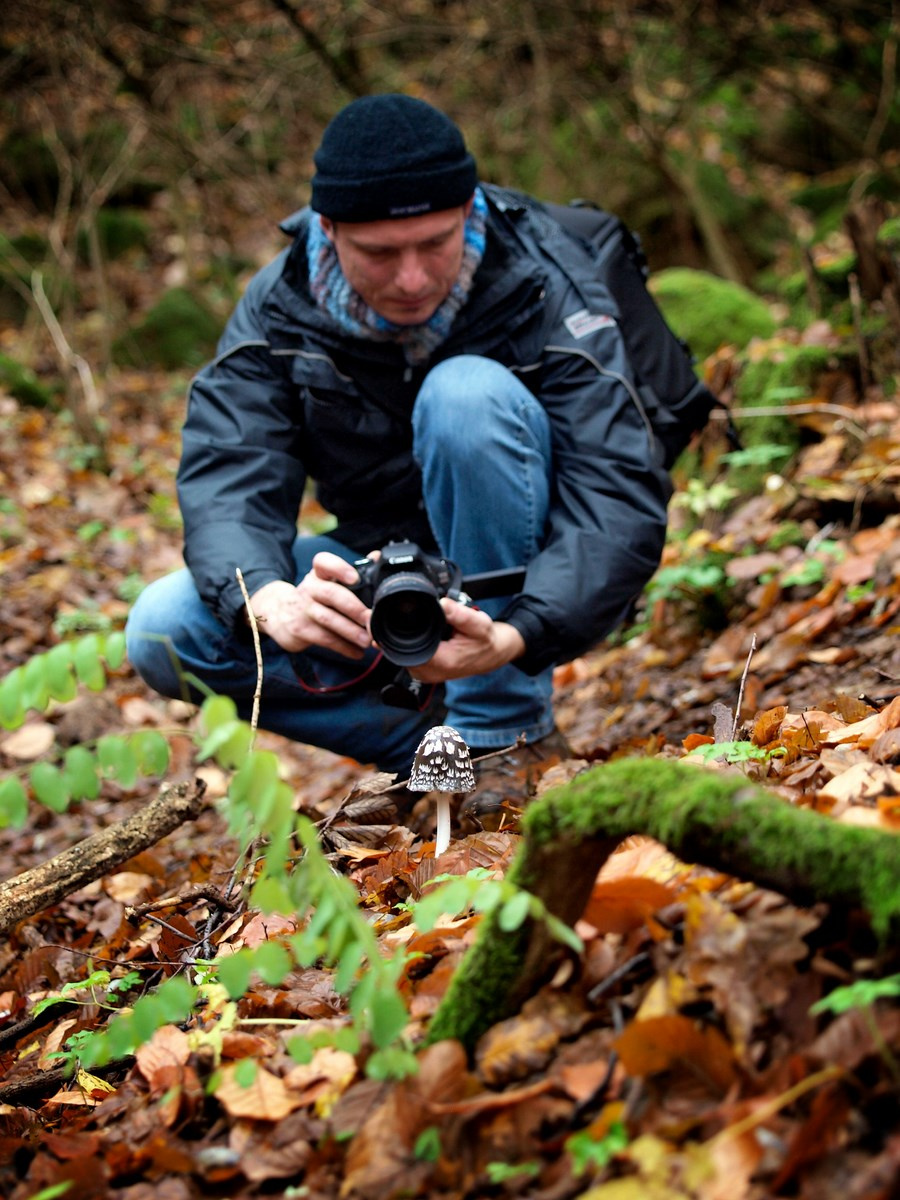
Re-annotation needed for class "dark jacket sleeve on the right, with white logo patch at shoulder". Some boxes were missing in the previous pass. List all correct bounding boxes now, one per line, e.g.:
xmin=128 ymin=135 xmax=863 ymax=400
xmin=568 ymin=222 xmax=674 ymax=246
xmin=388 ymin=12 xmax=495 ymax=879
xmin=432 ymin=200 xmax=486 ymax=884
xmin=502 ymin=310 xmax=671 ymax=674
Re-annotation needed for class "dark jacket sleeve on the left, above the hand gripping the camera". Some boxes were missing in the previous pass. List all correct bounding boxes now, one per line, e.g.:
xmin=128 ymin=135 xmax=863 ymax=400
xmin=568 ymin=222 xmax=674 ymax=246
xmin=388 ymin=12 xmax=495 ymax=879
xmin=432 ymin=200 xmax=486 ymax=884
xmin=176 ymin=260 xmax=306 ymax=628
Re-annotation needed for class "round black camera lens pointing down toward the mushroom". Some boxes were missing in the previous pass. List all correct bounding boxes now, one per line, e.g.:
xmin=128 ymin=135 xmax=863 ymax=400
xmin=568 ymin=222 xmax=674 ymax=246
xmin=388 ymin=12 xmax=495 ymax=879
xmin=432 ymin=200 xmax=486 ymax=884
xmin=372 ymin=572 xmax=446 ymax=667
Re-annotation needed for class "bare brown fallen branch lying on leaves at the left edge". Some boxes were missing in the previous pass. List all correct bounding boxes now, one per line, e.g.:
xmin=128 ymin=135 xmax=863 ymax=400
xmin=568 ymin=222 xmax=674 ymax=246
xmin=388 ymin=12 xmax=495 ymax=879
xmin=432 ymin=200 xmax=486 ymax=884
xmin=0 ymin=780 xmax=205 ymax=934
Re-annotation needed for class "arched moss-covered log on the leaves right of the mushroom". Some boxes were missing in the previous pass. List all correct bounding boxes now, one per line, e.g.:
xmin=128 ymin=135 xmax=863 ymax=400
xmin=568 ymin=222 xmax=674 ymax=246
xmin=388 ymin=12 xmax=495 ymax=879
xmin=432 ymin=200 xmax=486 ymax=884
xmin=428 ymin=758 xmax=900 ymax=1048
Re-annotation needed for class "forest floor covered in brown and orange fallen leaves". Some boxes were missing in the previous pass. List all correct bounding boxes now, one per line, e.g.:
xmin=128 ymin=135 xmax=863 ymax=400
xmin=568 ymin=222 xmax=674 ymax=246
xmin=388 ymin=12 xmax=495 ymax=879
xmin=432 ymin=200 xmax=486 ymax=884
xmin=0 ymin=372 xmax=900 ymax=1200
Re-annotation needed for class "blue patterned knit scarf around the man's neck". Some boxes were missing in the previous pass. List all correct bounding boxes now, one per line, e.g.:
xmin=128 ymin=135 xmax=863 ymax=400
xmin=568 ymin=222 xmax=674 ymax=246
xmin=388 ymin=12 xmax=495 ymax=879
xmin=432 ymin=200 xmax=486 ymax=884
xmin=306 ymin=187 xmax=487 ymax=366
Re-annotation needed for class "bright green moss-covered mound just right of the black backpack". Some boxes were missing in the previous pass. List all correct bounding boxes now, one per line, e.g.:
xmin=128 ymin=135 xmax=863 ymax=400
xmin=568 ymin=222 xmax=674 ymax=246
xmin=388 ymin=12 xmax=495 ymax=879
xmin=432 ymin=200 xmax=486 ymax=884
xmin=650 ymin=266 xmax=775 ymax=358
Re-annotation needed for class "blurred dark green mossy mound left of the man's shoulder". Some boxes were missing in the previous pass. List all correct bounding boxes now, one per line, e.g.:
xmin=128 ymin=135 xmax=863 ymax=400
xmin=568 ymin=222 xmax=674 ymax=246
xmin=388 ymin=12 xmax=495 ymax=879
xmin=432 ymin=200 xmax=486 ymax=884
xmin=113 ymin=288 xmax=222 ymax=371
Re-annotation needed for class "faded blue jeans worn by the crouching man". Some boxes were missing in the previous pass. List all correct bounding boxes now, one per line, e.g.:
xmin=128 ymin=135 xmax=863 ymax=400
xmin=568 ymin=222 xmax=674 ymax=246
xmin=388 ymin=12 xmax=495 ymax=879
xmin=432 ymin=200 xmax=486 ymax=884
xmin=126 ymin=355 xmax=553 ymax=773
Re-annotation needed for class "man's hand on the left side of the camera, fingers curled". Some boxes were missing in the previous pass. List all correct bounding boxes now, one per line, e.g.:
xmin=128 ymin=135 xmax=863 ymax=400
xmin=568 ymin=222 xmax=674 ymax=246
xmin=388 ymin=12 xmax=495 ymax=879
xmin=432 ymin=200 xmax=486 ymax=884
xmin=251 ymin=551 xmax=372 ymax=659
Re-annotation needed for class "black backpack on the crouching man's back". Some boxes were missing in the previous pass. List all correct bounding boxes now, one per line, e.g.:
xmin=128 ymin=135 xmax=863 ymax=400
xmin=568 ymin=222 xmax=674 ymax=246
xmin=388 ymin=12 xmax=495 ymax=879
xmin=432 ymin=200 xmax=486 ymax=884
xmin=540 ymin=200 xmax=739 ymax=468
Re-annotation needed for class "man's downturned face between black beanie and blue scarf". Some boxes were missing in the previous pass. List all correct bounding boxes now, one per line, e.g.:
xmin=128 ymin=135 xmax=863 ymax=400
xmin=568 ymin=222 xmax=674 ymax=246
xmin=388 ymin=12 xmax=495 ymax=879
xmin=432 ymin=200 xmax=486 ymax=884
xmin=322 ymin=200 xmax=472 ymax=325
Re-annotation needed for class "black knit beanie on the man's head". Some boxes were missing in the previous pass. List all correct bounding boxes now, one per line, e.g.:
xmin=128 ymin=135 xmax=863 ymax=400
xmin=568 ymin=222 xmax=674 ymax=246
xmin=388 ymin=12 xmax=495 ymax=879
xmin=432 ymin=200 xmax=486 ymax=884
xmin=311 ymin=94 xmax=478 ymax=221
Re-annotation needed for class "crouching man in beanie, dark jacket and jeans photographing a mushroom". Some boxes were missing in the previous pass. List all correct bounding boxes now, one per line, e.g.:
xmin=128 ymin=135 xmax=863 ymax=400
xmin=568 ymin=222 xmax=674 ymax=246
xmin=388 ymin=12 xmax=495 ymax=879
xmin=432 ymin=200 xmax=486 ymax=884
xmin=127 ymin=95 xmax=670 ymax=796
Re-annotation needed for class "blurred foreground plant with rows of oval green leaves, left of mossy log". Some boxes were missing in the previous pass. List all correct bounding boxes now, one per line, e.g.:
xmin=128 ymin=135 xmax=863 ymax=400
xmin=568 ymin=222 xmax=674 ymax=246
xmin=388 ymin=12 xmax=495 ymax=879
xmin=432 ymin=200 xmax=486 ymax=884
xmin=0 ymin=662 xmax=581 ymax=1094
